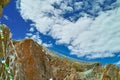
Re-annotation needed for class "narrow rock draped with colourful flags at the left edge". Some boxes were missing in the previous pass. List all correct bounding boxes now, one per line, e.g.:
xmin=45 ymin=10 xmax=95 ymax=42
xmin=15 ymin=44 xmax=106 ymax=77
xmin=0 ymin=24 xmax=17 ymax=80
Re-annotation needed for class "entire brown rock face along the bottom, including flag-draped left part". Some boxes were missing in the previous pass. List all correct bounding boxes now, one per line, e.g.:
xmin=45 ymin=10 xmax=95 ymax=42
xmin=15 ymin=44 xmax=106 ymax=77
xmin=0 ymin=25 xmax=120 ymax=80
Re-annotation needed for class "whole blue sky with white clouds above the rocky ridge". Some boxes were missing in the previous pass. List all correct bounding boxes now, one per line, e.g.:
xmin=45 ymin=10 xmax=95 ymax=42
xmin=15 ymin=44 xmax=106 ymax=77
xmin=0 ymin=0 xmax=120 ymax=65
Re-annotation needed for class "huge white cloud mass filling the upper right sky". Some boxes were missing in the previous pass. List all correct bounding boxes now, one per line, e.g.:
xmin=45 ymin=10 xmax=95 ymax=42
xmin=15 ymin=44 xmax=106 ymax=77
xmin=17 ymin=0 xmax=120 ymax=59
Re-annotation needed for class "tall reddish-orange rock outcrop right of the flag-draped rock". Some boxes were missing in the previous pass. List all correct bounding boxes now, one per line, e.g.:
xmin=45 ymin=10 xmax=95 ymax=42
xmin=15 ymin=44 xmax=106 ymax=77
xmin=15 ymin=39 xmax=52 ymax=80
